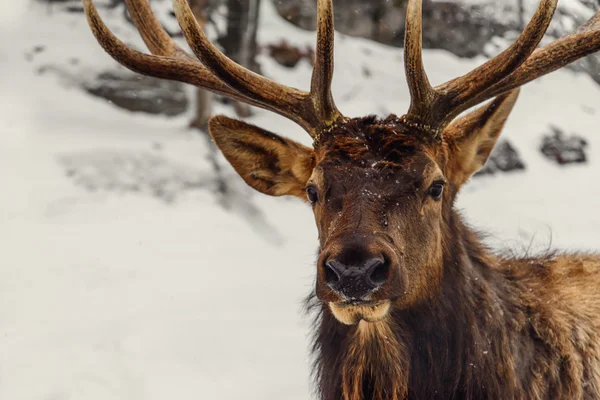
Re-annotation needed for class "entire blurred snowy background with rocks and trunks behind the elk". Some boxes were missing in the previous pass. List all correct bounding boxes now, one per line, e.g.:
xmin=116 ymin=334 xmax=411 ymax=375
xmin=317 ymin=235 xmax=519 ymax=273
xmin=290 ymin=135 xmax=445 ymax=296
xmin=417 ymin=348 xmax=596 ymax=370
xmin=0 ymin=0 xmax=600 ymax=400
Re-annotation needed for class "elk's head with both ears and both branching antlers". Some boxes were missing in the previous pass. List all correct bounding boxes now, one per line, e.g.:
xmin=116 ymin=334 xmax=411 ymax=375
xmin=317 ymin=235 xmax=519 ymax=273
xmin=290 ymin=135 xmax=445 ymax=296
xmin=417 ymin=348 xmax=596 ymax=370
xmin=84 ymin=0 xmax=600 ymax=324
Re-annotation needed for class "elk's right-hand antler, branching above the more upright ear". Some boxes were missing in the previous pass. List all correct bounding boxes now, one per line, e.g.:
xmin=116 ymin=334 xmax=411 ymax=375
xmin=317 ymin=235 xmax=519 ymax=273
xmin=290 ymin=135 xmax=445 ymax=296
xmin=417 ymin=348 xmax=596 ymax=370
xmin=403 ymin=0 xmax=600 ymax=135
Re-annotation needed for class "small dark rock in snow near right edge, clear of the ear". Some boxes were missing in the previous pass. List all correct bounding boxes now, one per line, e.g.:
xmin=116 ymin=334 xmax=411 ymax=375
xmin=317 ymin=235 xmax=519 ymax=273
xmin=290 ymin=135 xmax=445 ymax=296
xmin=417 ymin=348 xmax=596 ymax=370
xmin=540 ymin=126 xmax=587 ymax=165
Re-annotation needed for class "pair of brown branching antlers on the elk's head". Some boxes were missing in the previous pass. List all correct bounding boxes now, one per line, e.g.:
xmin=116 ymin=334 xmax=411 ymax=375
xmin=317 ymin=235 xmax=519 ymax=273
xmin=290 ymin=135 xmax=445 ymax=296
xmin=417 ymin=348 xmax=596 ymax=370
xmin=83 ymin=0 xmax=600 ymax=138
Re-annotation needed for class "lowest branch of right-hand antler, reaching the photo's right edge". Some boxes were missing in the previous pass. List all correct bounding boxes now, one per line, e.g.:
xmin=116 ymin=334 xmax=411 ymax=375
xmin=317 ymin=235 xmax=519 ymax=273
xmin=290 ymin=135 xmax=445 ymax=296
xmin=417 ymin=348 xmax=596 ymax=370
xmin=467 ymin=11 xmax=600 ymax=107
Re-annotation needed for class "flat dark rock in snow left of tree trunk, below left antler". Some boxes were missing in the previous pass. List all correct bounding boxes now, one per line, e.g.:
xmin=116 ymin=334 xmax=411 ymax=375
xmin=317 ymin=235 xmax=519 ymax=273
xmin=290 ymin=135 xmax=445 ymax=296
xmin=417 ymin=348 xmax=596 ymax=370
xmin=84 ymin=71 xmax=189 ymax=117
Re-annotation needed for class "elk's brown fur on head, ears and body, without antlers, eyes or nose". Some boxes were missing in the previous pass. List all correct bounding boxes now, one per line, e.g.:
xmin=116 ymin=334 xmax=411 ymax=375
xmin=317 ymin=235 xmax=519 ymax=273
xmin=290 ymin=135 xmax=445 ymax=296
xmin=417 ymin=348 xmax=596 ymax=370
xmin=211 ymin=97 xmax=600 ymax=400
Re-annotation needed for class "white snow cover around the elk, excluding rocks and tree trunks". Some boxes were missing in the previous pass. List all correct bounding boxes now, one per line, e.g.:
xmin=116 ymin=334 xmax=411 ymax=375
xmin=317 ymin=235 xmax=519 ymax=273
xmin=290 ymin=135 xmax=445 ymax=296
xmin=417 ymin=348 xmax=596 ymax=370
xmin=0 ymin=2 xmax=600 ymax=400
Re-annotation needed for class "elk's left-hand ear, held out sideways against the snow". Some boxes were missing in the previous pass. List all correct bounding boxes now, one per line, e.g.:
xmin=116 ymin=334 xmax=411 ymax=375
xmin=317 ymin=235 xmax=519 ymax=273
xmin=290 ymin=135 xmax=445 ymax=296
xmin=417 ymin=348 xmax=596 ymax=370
xmin=209 ymin=115 xmax=315 ymax=199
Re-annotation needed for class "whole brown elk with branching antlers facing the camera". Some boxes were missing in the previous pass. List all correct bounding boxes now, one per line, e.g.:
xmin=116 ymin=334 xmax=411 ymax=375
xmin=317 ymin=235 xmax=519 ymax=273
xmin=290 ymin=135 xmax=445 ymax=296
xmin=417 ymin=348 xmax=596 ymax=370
xmin=83 ymin=0 xmax=600 ymax=400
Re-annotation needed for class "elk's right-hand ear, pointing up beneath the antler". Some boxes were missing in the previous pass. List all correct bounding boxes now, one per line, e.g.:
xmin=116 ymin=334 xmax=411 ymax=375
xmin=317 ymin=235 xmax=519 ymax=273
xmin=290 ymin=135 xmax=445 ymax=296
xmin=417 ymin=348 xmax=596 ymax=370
xmin=443 ymin=89 xmax=519 ymax=187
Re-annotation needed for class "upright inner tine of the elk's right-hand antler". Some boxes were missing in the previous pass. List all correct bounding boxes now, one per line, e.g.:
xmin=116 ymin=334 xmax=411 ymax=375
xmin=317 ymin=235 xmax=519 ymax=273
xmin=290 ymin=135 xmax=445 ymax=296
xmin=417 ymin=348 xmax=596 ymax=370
xmin=404 ymin=0 xmax=436 ymax=119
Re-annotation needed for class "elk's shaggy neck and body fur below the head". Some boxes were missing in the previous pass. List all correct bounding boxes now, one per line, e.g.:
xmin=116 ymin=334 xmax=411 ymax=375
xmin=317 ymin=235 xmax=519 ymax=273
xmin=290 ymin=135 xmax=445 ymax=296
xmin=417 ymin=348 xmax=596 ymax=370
xmin=310 ymin=216 xmax=600 ymax=400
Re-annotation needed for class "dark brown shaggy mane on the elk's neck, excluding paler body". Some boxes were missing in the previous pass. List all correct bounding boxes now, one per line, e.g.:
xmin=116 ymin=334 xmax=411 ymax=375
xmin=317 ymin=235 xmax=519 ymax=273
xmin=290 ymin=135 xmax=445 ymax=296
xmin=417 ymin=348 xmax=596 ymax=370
xmin=313 ymin=205 xmax=533 ymax=400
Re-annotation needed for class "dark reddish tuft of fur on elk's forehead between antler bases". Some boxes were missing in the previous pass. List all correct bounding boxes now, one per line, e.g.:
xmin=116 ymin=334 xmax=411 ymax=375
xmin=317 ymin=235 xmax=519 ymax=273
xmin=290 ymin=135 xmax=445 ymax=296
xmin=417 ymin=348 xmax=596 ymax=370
xmin=316 ymin=115 xmax=441 ymax=167
